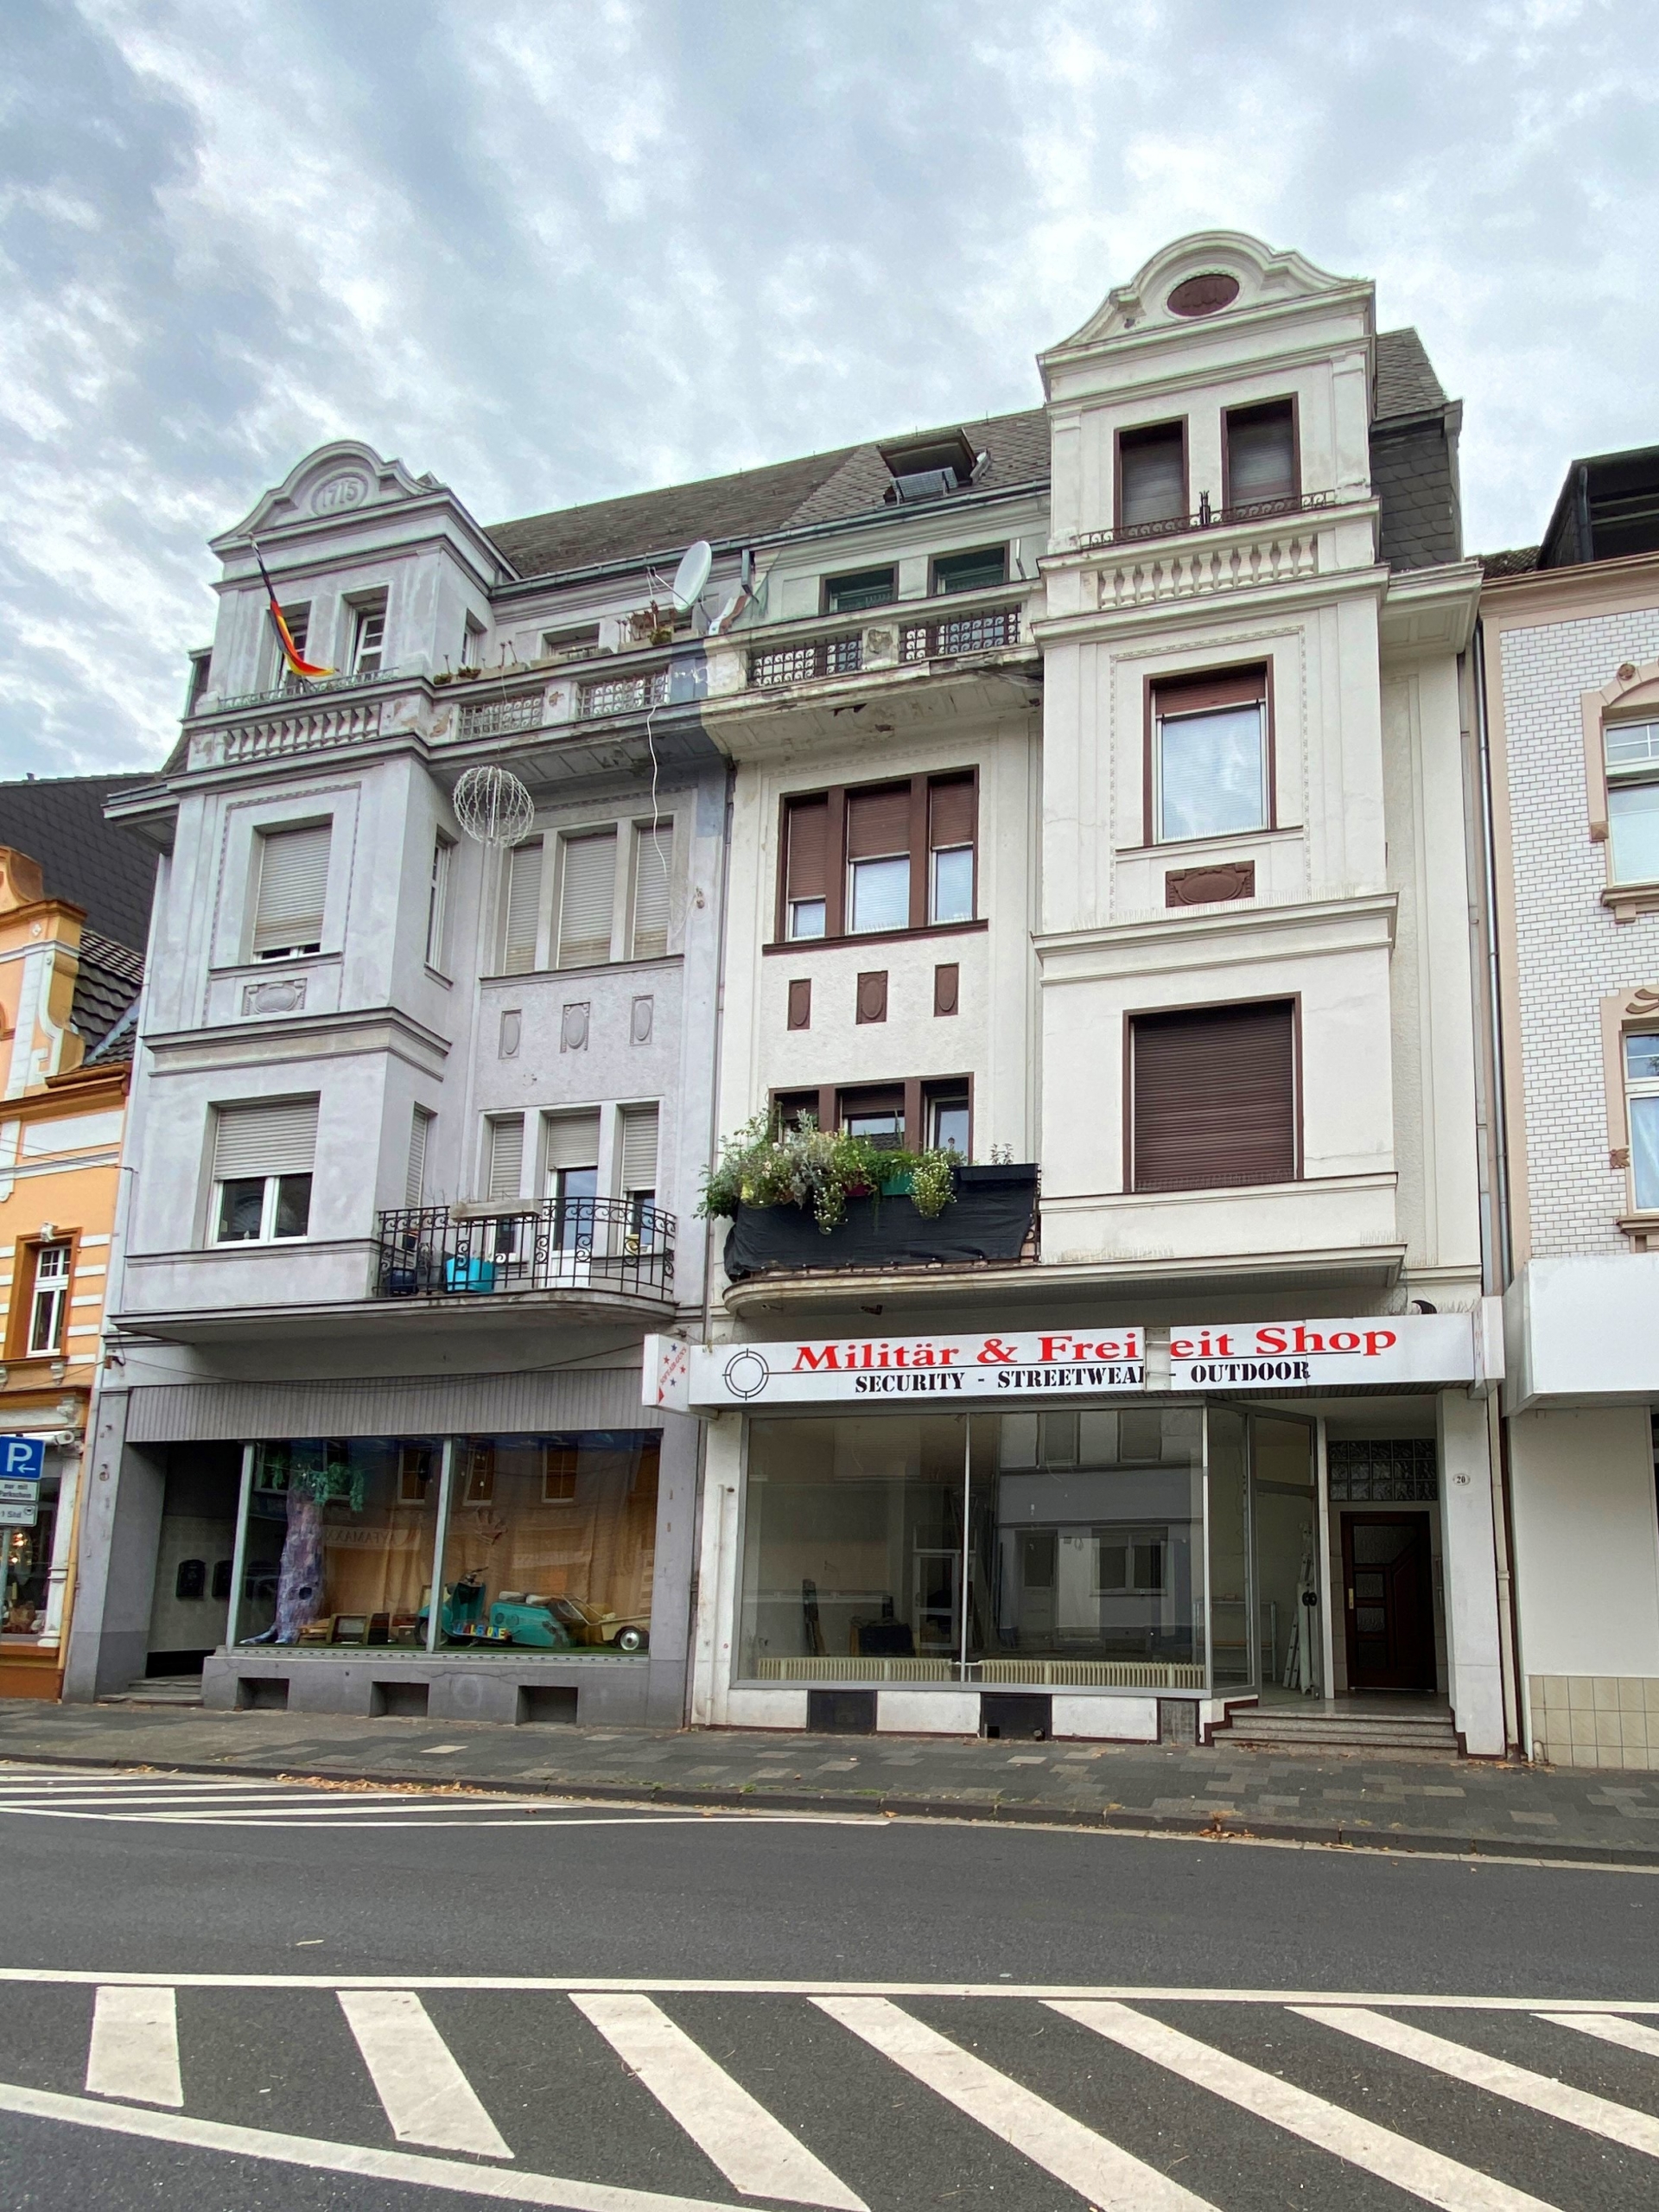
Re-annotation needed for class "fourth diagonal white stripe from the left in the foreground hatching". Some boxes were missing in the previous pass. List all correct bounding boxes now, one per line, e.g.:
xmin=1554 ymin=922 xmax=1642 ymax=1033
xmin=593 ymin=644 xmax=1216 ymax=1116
xmin=814 ymin=1998 xmax=1212 ymax=2212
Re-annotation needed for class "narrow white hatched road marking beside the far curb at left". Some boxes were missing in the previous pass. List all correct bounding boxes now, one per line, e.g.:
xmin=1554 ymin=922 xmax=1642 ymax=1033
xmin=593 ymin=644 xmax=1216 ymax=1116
xmin=0 ymin=1767 xmax=844 ymax=1832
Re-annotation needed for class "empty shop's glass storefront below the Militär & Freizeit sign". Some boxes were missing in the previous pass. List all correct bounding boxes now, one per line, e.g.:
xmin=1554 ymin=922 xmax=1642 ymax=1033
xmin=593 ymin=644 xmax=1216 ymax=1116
xmin=736 ymin=1405 xmax=1319 ymax=1692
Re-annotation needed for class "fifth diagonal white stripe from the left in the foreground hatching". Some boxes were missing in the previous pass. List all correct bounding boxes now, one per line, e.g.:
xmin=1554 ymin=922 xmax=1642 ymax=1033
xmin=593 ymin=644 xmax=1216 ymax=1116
xmin=1046 ymin=1998 xmax=1548 ymax=2212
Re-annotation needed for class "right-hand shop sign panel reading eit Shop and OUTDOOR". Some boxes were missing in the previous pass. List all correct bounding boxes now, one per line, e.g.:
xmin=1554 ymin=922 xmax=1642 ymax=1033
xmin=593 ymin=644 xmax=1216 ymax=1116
xmin=1170 ymin=1314 xmax=1476 ymax=1389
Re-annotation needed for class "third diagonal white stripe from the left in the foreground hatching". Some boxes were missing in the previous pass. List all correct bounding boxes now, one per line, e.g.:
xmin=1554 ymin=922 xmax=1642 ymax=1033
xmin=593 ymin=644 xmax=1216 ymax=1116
xmin=570 ymin=1995 xmax=868 ymax=2212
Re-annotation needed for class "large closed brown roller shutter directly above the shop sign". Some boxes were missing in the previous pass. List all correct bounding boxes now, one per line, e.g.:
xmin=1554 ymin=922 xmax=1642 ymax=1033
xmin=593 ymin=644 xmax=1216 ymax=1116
xmin=1130 ymin=1000 xmax=1296 ymax=1190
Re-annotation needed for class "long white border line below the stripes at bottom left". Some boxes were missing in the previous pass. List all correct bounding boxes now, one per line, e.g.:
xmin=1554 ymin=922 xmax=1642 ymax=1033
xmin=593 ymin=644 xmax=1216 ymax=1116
xmin=0 ymin=2082 xmax=750 ymax=2212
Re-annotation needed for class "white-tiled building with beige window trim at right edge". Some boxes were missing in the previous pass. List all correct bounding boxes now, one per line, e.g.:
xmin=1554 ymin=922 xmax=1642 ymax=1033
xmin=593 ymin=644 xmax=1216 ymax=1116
xmin=1480 ymin=449 xmax=1659 ymax=1770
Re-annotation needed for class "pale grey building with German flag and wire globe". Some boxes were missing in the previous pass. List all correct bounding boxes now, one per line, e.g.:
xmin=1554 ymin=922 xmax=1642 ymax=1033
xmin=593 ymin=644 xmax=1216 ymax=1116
xmin=67 ymin=442 xmax=726 ymax=1723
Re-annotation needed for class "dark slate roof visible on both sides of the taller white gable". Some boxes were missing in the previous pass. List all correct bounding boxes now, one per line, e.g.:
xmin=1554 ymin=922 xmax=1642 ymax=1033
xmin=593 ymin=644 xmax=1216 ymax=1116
xmin=489 ymin=329 xmax=1462 ymax=577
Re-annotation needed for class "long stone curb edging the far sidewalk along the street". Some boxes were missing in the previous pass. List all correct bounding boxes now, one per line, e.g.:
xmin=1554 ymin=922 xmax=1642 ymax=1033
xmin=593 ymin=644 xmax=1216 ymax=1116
xmin=0 ymin=1738 xmax=1659 ymax=1872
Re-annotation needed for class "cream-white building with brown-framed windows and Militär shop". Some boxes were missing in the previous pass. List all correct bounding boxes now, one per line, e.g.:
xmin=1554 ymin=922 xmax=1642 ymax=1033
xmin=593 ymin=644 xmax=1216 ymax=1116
xmin=677 ymin=232 xmax=1510 ymax=1754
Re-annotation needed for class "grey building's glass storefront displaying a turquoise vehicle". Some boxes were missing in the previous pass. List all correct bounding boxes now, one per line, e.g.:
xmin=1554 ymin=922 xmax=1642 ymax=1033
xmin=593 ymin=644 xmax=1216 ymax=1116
xmin=230 ymin=1429 xmax=661 ymax=1656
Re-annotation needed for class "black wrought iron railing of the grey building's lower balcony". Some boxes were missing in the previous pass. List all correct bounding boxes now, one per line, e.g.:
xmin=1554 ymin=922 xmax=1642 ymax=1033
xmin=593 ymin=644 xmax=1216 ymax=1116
xmin=374 ymin=1199 xmax=675 ymax=1300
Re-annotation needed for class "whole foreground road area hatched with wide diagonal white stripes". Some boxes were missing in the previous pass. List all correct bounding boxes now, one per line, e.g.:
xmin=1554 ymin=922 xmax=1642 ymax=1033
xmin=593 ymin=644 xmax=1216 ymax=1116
xmin=0 ymin=1968 xmax=1659 ymax=2212
